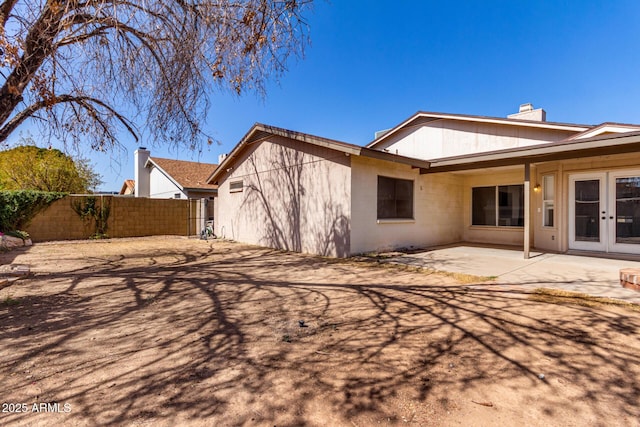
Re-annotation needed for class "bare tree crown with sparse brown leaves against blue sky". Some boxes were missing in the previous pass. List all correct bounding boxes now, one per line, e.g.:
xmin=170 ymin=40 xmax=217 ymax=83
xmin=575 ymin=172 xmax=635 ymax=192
xmin=0 ymin=0 xmax=311 ymax=149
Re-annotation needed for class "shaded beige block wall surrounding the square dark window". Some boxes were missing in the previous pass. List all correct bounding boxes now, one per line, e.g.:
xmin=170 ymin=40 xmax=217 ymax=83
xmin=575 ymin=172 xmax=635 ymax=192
xmin=351 ymin=157 xmax=463 ymax=254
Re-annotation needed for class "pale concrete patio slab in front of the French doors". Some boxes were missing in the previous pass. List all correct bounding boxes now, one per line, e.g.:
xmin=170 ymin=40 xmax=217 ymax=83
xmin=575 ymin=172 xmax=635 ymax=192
xmin=386 ymin=245 xmax=640 ymax=304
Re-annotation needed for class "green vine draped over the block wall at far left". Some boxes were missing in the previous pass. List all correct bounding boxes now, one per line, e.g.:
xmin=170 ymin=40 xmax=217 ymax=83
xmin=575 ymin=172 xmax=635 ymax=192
xmin=0 ymin=190 xmax=66 ymax=231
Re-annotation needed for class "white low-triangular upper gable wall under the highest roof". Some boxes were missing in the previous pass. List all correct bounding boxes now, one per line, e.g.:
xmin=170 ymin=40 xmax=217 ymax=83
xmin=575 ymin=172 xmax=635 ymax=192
xmin=376 ymin=120 xmax=575 ymax=160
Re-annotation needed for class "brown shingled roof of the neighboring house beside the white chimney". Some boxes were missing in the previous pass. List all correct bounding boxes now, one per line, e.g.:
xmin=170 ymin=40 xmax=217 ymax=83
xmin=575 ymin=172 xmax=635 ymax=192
xmin=145 ymin=157 xmax=218 ymax=191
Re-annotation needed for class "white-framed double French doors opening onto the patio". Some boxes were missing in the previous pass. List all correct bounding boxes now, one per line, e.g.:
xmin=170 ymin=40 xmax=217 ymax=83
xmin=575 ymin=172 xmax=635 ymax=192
xmin=569 ymin=170 xmax=640 ymax=254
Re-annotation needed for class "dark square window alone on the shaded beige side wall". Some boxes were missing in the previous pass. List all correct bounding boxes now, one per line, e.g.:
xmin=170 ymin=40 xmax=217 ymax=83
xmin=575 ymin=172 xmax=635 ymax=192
xmin=378 ymin=176 xmax=413 ymax=219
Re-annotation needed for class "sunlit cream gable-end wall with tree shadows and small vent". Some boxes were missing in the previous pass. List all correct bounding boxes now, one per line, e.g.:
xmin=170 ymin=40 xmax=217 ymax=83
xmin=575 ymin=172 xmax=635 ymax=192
xmin=215 ymin=137 xmax=351 ymax=257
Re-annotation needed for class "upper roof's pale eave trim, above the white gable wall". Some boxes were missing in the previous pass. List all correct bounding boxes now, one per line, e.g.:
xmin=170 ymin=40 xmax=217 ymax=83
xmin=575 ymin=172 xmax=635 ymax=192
xmin=366 ymin=111 xmax=593 ymax=148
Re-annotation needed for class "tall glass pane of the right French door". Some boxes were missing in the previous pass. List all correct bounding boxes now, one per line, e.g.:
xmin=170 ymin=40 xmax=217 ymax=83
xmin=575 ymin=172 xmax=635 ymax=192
xmin=616 ymin=176 xmax=640 ymax=244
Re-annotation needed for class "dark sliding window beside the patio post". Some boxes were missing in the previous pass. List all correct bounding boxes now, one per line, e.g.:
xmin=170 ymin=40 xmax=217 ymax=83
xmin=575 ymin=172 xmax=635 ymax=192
xmin=471 ymin=184 xmax=524 ymax=227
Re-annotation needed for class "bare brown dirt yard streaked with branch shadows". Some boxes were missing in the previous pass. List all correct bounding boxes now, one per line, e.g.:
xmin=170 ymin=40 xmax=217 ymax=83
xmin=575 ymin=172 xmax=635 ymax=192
xmin=0 ymin=237 xmax=640 ymax=426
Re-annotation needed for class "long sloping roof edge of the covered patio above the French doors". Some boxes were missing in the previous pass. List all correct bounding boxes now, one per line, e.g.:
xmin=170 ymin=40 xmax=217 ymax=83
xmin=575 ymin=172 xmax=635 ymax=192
xmin=426 ymin=131 xmax=640 ymax=173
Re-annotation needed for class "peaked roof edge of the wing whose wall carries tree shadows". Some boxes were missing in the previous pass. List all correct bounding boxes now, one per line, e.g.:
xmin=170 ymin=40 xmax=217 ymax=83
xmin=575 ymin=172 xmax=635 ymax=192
xmin=207 ymin=123 xmax=429 ymax=182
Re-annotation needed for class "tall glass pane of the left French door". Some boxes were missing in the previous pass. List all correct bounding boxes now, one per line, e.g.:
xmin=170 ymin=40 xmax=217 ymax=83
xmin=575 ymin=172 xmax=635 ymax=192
xmin=575 ymin=179 xmax=600 ymax=242
